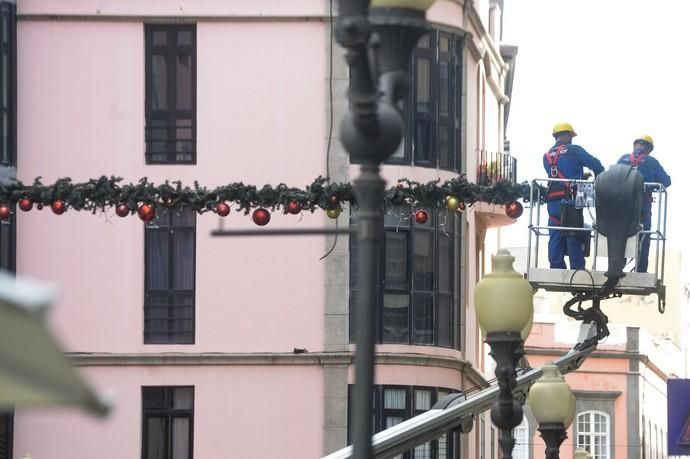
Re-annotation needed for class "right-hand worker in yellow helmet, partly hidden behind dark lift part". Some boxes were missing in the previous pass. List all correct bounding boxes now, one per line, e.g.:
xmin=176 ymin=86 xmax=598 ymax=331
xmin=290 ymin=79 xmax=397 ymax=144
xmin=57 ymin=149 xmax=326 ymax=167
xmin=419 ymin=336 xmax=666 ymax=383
xmin=618 ymin=135 xmax=671 ymax=273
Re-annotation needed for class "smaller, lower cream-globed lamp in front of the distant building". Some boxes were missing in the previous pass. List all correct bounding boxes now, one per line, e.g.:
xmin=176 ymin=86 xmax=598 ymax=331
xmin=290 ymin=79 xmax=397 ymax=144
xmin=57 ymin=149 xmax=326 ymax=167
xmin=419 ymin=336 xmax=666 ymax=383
xmin=527 ymin=365 xmax=575 ymax=459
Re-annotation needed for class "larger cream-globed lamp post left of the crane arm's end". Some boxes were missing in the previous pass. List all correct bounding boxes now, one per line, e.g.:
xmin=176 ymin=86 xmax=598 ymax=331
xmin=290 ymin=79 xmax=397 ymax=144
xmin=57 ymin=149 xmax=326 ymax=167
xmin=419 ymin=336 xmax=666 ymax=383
xmin=474 ymin=249 xmax=534 ymax=459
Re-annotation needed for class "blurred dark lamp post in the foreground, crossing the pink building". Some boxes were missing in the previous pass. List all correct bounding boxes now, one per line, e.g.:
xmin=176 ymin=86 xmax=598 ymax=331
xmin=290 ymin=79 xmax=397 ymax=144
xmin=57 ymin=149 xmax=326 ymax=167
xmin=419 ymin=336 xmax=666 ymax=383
xmin=335 ymin=0 xmax=434 ymax=459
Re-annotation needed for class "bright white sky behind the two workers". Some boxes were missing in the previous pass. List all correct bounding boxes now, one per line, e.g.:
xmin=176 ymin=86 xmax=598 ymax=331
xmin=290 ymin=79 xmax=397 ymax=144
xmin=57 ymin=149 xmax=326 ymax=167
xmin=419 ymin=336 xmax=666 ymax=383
xmin=503 ymin=0 xmax=690 ymax=256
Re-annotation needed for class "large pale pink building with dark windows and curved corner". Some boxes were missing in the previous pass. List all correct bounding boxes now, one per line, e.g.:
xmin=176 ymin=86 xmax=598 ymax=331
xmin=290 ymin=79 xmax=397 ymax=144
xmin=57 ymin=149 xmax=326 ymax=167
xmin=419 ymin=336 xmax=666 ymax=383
xmin=0 ymin=0 xmax=517 ymax=459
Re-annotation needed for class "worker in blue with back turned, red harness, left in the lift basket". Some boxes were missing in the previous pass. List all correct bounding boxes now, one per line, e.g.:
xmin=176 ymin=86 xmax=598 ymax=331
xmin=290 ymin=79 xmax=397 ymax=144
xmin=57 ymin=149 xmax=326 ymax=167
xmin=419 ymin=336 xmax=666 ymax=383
xmin=544 ymin=123 xmax=604 ymax=269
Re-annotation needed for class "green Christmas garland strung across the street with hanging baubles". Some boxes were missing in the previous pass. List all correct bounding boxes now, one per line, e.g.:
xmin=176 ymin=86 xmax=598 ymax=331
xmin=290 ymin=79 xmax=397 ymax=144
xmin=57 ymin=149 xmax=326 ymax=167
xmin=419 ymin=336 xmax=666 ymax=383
xmin=0 ymin=175 xmax=529 ymax=214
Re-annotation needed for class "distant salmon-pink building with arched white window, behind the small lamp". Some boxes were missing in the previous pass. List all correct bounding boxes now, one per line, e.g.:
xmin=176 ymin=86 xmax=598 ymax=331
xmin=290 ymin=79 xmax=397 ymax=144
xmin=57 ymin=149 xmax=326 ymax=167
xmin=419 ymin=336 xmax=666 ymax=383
xmin=516 ymin=321 xmax=685 ymax=459
